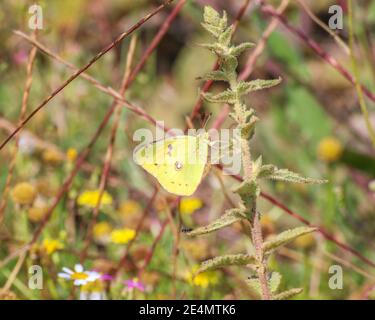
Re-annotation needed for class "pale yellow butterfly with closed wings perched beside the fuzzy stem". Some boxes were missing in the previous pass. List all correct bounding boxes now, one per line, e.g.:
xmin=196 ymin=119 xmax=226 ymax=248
xmin=134 ymin=133 xmax=210 ymax=196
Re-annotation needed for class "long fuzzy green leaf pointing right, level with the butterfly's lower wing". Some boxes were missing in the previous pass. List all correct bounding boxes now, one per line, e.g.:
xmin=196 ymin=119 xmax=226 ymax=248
xmin=258 ymin=165 xmax=327 ymax=184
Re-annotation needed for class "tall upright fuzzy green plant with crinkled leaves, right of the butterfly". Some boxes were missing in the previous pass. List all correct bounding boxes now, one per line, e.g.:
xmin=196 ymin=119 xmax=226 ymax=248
xmin=197 ymin=7 xmax=326 ymax=299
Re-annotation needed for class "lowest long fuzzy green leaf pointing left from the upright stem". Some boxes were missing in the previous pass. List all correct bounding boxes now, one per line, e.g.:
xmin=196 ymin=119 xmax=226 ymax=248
xmin=198 ymin=253 xmax=255 ymax=272
